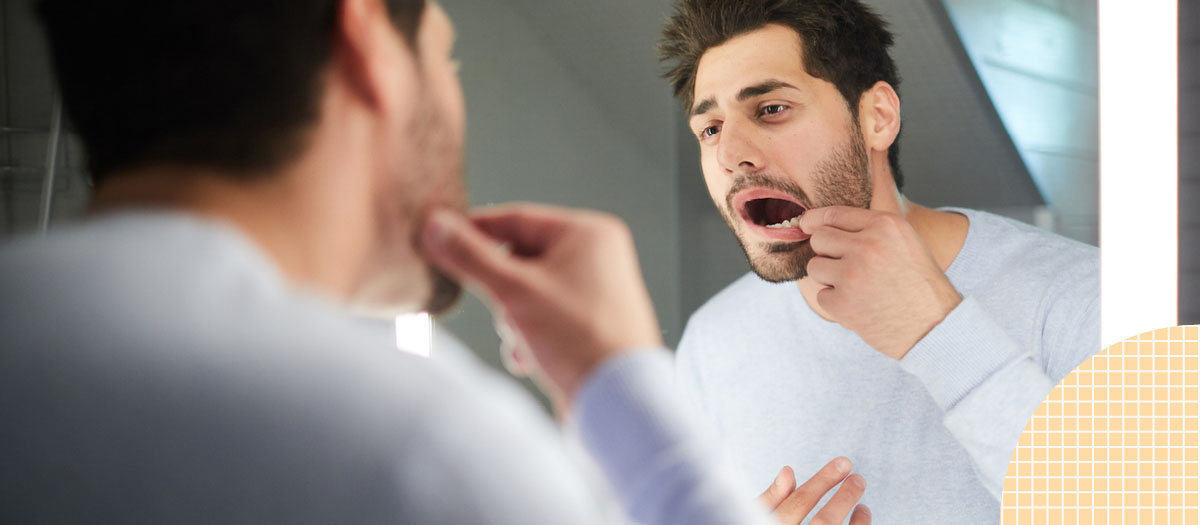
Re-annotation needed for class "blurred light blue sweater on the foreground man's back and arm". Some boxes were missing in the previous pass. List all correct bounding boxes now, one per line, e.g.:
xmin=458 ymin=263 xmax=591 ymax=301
xmin=0 ymin=212 xmax=769 ymax=525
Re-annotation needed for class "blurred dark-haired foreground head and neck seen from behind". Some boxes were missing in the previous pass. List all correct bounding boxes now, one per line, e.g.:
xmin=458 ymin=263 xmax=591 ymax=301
xmin=38 ymin=0 xmax=466 ymax=313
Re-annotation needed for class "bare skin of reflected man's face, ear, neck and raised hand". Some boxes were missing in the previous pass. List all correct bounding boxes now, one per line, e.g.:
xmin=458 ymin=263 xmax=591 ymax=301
xmin=689 ymin=25 xmax=968 ymax=360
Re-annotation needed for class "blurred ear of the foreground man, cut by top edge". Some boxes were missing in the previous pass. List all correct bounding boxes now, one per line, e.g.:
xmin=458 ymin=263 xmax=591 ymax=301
xmin=335 ymin=0 xmax=413 ymax=113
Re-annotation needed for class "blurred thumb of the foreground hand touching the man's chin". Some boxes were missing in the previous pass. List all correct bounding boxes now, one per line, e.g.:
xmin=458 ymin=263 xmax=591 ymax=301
xmin=421 ymin=210 xmax=520 ymax=298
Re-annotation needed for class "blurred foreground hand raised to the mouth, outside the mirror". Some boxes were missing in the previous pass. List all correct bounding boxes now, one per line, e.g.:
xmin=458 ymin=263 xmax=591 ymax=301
xmin=422 ymin=205 xmax=662 ymax=405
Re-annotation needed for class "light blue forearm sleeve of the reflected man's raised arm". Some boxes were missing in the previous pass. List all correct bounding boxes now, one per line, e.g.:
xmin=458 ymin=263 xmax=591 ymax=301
xmin=900 ymin=297 xmax=1057 ymax=500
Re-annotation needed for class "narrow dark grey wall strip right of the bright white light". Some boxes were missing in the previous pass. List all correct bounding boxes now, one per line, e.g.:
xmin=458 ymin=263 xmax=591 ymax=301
xmin=1180 ymin=0 xmax=1200 ymax=325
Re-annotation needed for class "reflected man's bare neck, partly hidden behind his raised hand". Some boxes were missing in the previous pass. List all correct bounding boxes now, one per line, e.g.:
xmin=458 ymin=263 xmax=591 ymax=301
xmin=796 ymin=167 xmax=968 ymax=321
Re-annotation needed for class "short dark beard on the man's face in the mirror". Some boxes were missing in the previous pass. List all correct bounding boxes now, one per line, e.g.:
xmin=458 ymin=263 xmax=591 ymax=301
xmin=721 ymin=125 xmax=872 ymax=283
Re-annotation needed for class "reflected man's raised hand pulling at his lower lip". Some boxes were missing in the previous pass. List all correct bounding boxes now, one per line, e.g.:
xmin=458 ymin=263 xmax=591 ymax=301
xmin=800 ymin=206 xmax=962 ymax=360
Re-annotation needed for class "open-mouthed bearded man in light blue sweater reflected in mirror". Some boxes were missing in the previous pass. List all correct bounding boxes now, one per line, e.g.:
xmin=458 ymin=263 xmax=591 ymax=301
xmin=660 ymin=0 xmax=1099 ymax=523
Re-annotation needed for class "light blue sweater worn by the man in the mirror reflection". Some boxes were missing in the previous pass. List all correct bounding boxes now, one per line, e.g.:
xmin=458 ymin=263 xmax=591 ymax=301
xmin=677 ymin=209 xmax=1099 ymax=524
